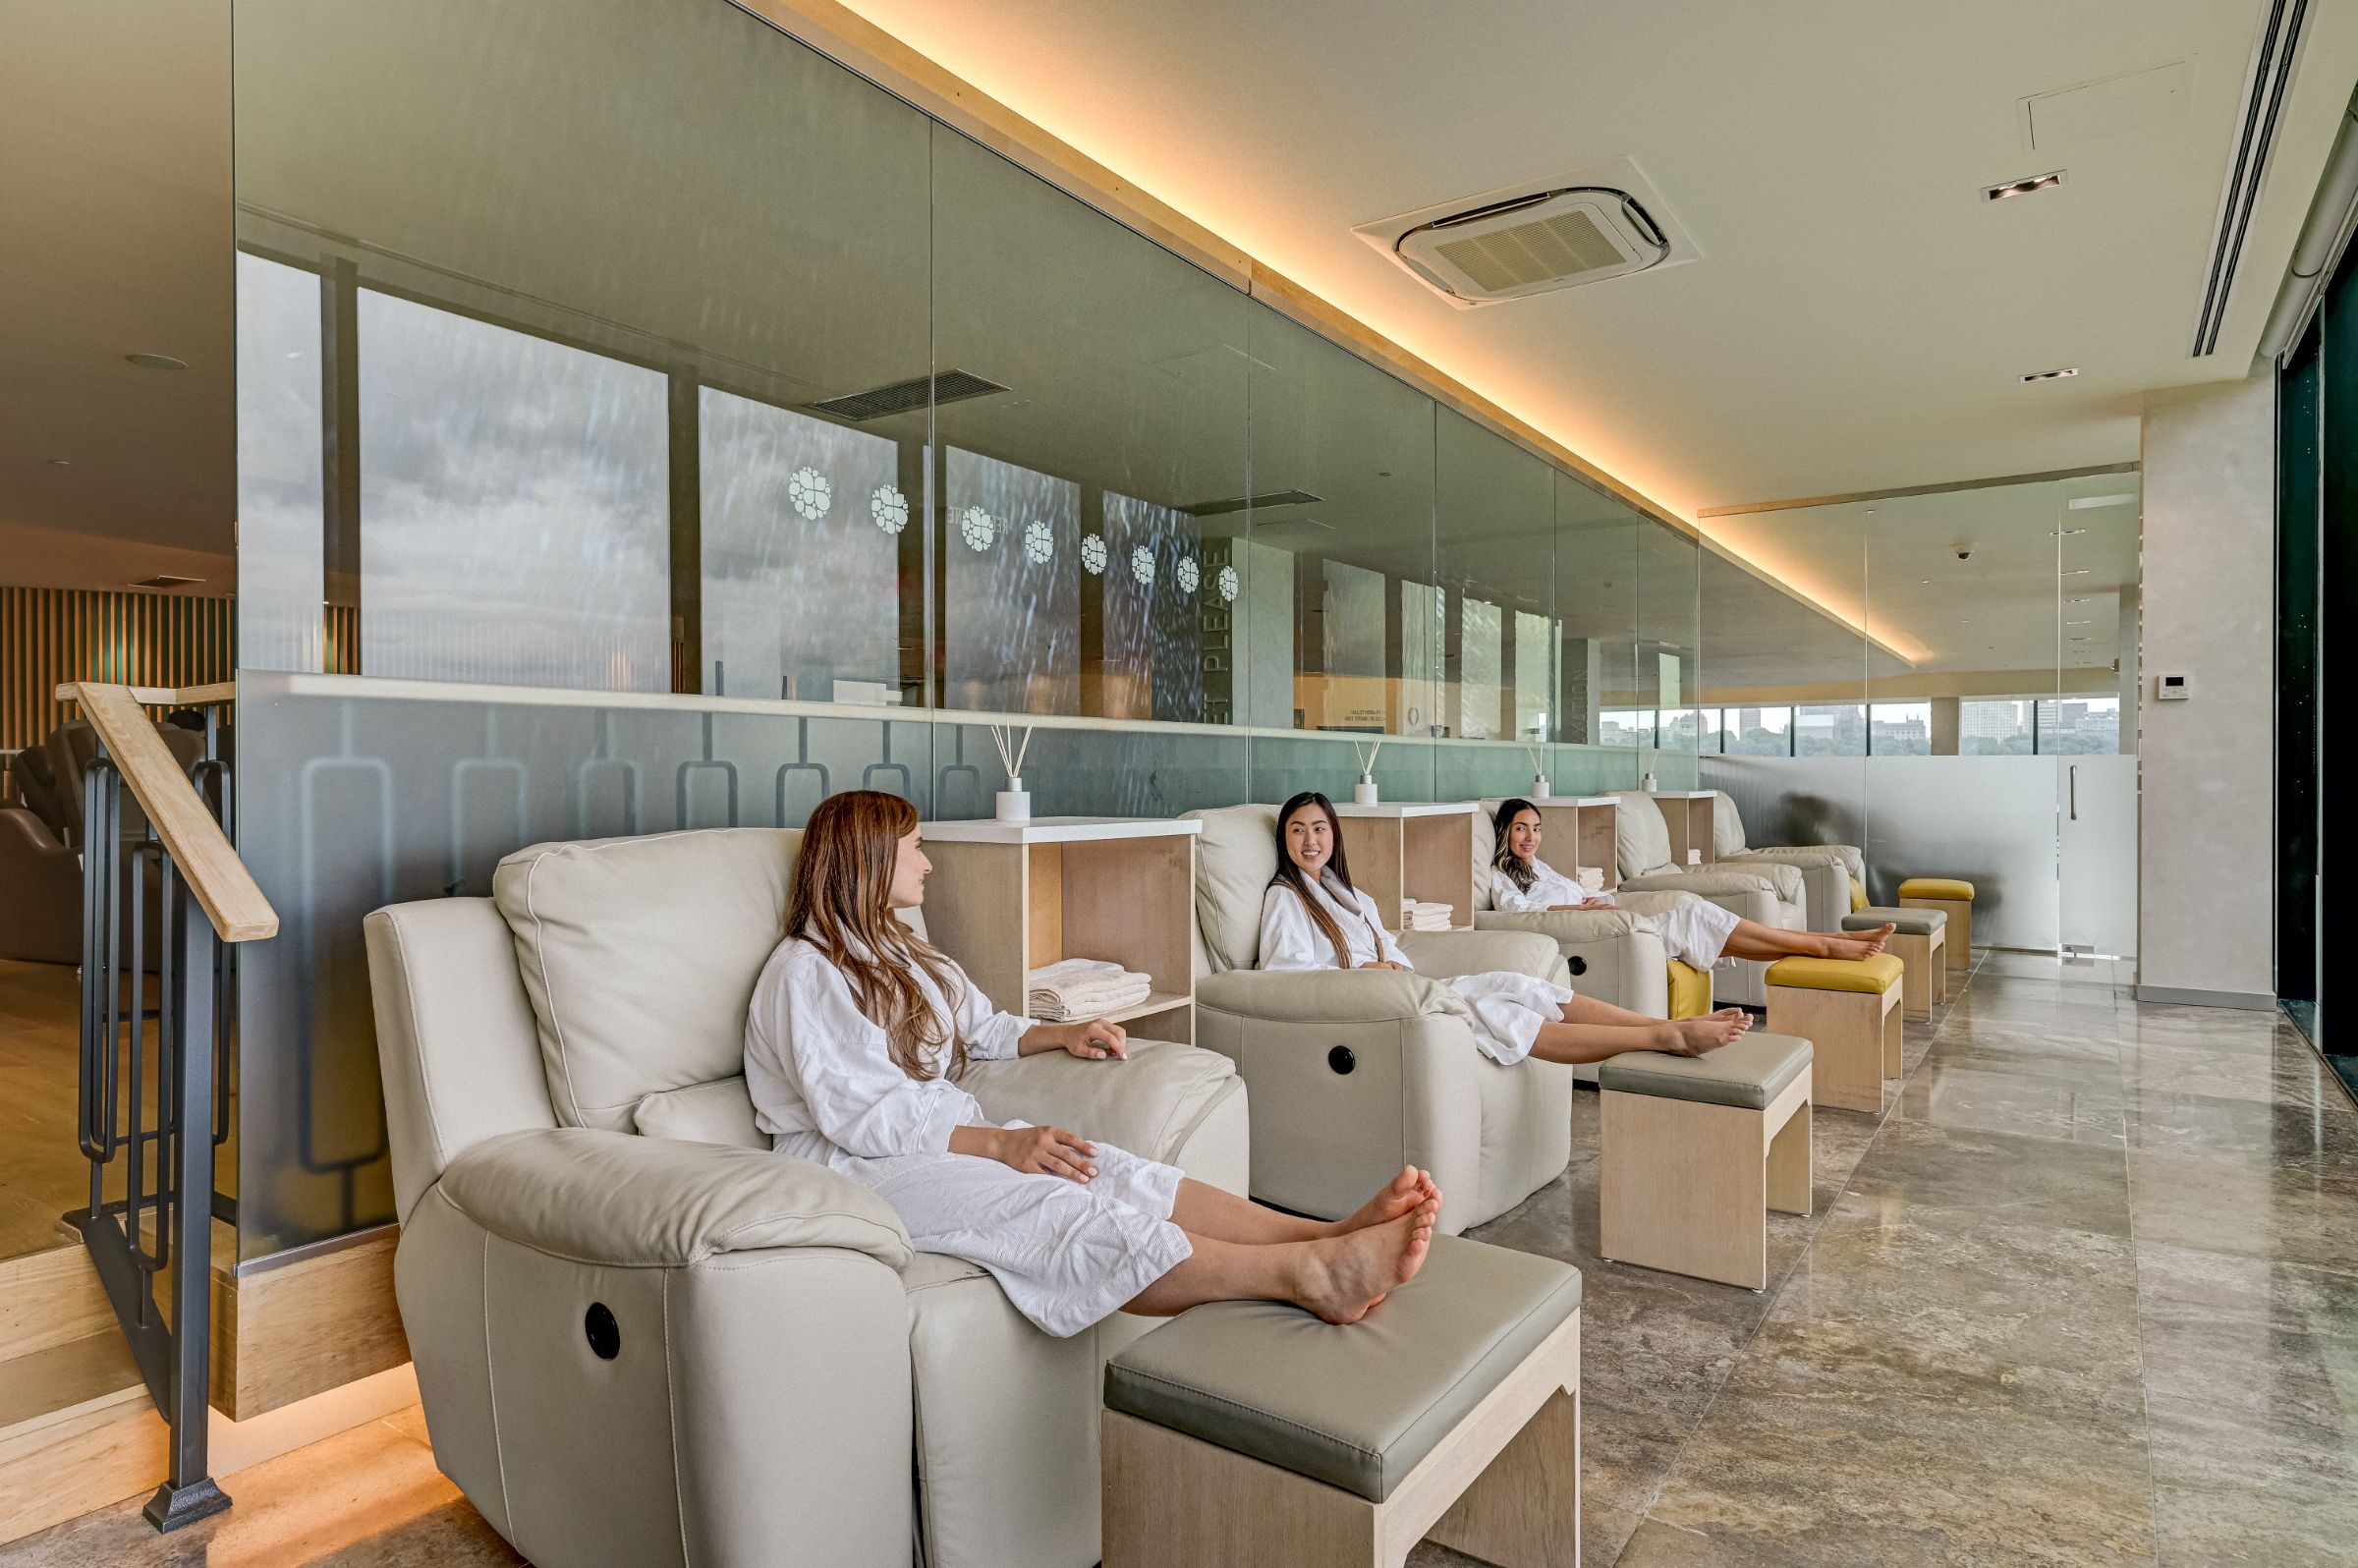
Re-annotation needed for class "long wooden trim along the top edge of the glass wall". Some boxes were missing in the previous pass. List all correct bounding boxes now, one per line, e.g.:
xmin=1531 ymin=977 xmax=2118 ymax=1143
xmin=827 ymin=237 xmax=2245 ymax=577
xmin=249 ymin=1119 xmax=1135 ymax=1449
xmin=731 ymin=0 xmax=1698 ymax=537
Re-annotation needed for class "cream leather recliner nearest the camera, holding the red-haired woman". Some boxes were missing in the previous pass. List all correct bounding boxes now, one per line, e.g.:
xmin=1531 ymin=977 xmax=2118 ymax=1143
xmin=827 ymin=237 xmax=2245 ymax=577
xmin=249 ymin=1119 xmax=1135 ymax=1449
xmin=367 ymin=827 xmax=1248 ymax=1568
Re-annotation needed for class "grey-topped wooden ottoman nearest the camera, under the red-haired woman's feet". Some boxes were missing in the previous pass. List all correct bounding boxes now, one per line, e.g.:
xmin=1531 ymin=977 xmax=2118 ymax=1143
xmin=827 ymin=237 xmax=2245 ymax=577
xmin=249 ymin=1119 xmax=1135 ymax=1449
xmin=1103 ymin=1236 xmax=1580 ymax=1568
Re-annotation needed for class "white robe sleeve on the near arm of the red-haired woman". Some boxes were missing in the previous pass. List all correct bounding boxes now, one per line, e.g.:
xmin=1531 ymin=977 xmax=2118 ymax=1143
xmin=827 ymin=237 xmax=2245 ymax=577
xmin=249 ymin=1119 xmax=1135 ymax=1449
xmin=755 ymin=943 xmax=985 ymax=1160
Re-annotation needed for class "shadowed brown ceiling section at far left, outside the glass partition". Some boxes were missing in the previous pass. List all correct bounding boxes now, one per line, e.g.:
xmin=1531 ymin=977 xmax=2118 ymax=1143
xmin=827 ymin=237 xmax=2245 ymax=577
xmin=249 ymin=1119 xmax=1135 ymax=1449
xmin=0 ymin=0 xmax=236 ymax=594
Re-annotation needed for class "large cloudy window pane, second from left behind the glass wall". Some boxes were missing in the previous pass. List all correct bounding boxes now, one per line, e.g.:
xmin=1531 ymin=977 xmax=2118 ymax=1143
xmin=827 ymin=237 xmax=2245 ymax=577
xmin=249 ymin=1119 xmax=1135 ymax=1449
xmin=361 ymin=290 xmax=672 ymax=691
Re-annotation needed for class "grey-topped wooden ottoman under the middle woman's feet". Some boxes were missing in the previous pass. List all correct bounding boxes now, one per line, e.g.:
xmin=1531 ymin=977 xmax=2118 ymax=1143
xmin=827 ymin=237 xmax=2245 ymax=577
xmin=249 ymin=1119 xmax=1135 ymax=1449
xmin=1597 ymin=1033 xmax=1811 ymax=1290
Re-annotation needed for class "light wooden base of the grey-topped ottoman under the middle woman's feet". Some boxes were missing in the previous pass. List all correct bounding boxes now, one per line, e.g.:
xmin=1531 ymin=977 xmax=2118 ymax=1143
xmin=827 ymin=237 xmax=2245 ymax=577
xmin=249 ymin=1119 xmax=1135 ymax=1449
xmin=1597 ymin=1075 xmax=1823 ymax=1290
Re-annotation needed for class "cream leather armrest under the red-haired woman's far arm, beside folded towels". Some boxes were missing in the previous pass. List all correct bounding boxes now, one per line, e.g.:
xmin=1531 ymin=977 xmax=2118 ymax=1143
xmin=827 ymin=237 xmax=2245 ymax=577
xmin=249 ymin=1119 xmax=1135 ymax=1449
xmin=957 ymin=1039 xmax=1243 ymax=1162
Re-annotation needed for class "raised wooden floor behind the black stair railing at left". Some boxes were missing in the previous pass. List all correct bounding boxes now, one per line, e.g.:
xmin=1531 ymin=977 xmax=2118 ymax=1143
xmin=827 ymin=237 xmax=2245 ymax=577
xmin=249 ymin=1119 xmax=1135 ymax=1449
xmin=0 ymin=960 xmax=238 ymax=1260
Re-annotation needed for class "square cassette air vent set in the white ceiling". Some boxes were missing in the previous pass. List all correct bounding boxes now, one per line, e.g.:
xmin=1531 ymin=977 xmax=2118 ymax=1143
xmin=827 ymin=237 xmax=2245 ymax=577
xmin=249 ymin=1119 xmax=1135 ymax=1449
xmin=1356 ymin=158 xmax=1698 ymax=308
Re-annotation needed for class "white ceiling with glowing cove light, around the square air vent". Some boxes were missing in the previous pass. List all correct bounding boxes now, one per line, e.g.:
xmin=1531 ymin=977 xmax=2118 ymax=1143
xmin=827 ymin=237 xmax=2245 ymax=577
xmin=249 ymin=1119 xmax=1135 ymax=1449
xmin=847 ymin=0 xmax=2358 ymax=514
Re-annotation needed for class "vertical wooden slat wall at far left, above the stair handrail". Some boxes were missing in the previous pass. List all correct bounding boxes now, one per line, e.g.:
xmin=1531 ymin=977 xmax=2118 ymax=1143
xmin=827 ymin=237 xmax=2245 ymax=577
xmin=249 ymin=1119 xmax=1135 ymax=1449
xmin=0 ymin=588 xmax=238 ymax=750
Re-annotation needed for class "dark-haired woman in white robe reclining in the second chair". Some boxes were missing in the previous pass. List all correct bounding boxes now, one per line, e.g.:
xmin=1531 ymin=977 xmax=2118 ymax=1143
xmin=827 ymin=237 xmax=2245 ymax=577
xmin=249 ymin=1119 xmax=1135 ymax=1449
xmin=1260 ymin=792 xmax=1752 ymax=1063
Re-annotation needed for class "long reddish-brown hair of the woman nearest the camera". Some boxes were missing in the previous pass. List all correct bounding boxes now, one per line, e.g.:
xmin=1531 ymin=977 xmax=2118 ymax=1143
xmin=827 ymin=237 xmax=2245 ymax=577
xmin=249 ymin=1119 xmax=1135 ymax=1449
xmin=785 ymin=790 xmax=967 ymax=1083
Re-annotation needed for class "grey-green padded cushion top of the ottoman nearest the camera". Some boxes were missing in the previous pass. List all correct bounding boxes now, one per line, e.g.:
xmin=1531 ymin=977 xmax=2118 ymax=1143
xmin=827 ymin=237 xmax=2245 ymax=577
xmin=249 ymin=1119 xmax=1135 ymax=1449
xmin=1106 ymin=1236 xmax=1580 ymax=1502
